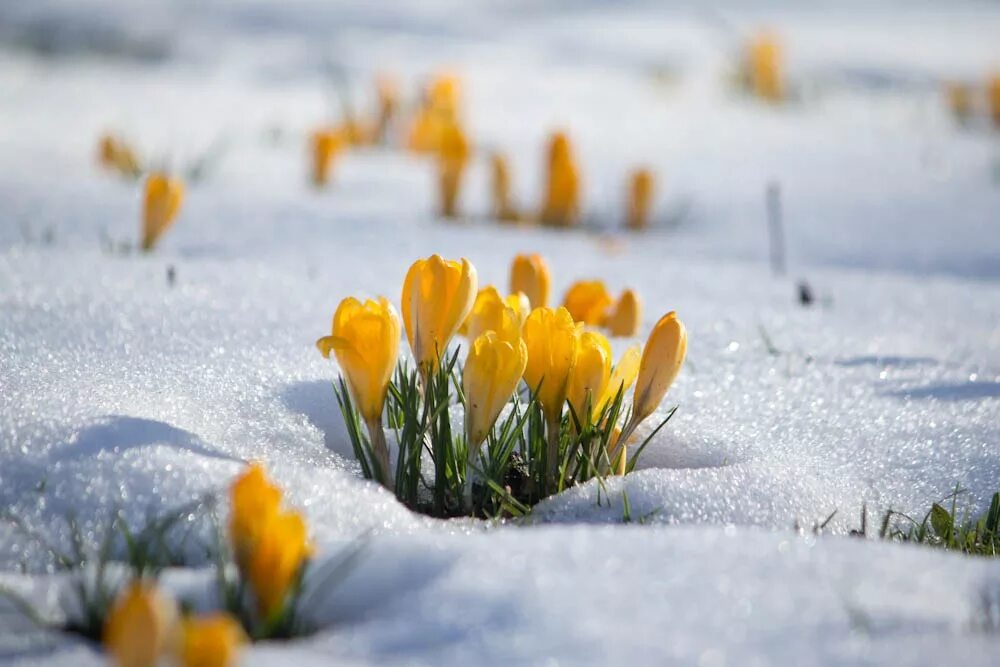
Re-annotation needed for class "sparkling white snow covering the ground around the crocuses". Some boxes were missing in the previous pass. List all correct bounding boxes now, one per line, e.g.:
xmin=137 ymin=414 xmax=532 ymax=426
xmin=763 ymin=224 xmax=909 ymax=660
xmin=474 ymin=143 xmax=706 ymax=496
xmin=0 ymin=0 xmax=1000 ymax=665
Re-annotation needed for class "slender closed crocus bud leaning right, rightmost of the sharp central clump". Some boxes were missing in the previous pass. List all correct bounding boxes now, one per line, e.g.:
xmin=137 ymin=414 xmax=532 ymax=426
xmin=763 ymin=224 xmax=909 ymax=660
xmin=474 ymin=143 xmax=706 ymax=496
xmin=625 ymin=311 xmax=687 ymax=426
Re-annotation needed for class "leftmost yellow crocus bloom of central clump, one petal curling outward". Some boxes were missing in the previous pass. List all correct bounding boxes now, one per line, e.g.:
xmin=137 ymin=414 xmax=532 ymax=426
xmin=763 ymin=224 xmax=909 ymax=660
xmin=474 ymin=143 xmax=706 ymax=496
xmin=316 ymin=297 xmax=400 ymax=423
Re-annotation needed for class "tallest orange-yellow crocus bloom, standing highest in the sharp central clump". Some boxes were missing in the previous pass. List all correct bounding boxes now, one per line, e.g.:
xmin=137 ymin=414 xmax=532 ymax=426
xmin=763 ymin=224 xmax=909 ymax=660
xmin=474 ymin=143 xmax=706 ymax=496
xmin=402 ymin=255 xmax=478 ymax=373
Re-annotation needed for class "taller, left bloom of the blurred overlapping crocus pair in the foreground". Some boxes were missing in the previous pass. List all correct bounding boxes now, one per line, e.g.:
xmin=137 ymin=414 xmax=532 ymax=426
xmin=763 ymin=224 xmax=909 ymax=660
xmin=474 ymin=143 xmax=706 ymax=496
xmin=229 ymin=463 xmax=281 ymax=567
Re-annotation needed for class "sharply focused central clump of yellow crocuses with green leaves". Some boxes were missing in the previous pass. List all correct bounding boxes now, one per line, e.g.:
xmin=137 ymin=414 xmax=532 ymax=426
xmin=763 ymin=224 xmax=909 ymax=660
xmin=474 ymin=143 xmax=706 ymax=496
xmin=317 ymin=250 xmax=687 ymax=516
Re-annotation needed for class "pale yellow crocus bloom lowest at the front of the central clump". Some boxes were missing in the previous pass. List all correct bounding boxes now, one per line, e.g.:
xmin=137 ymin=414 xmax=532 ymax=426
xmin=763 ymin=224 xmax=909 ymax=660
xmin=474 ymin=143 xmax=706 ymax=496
xmin=462 ymin=318 xmax=528 ymax=448
